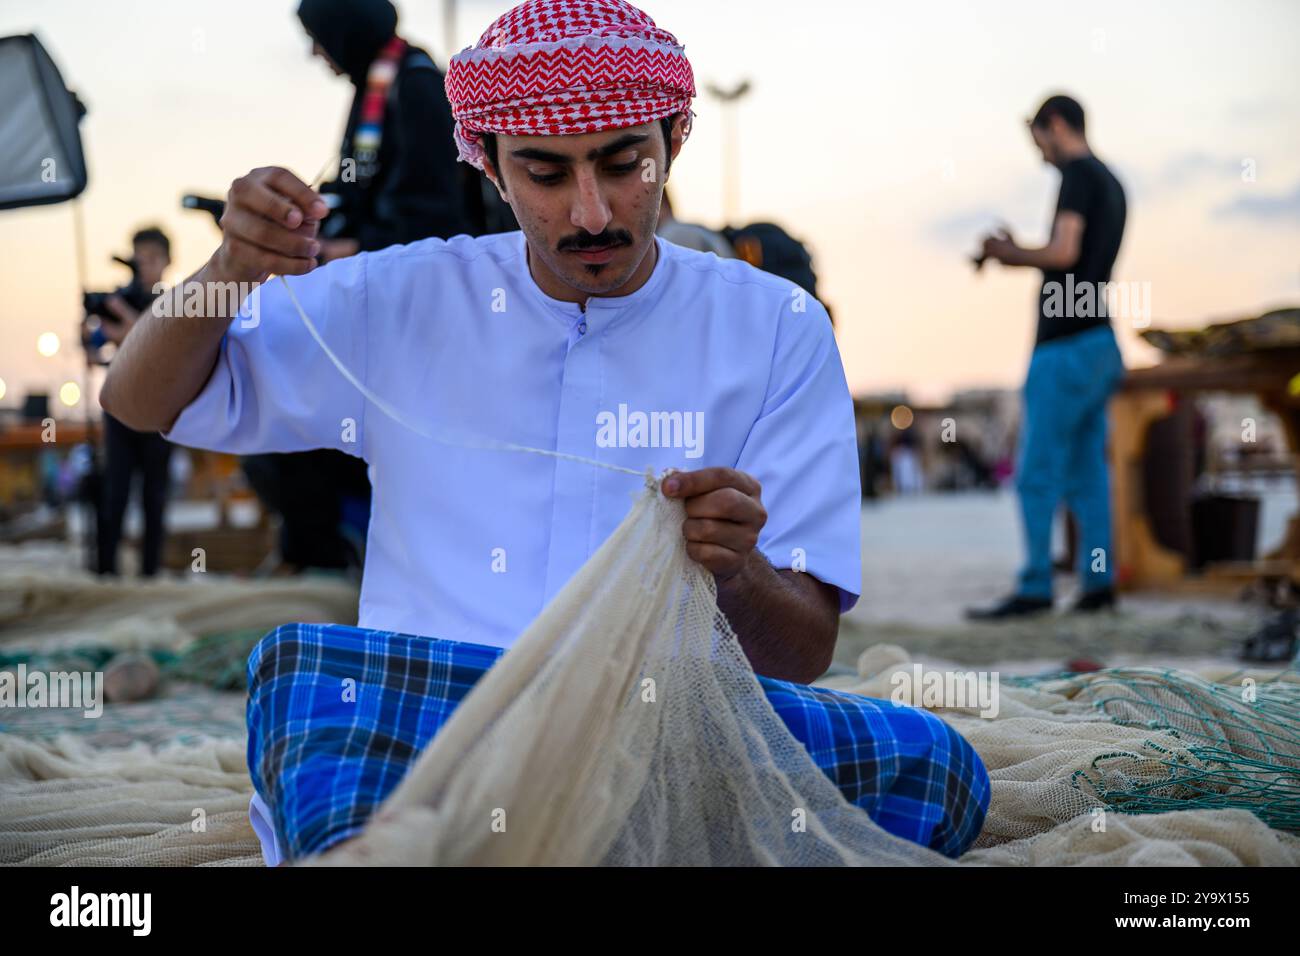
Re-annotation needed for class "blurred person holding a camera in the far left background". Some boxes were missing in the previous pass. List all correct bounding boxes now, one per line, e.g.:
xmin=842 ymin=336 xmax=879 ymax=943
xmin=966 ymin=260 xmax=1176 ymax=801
xmin=82 ymin=228 xmax=172 ymax=578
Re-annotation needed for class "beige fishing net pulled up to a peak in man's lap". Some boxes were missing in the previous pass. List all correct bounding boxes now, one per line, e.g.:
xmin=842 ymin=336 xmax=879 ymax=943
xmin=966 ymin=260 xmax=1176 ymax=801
xmin=313 ymin=486 xmax=944 ymax=865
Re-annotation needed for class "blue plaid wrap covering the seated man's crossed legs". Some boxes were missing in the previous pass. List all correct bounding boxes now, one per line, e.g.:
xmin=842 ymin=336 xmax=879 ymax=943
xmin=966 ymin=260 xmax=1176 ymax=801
xmin=248 ymin=624 xmax=989 ymax=860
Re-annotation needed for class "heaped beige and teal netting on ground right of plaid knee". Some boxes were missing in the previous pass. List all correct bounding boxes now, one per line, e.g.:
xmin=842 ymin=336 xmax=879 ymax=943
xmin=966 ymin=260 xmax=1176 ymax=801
xmin=818 ymin=645 xmax=1300 ymax=866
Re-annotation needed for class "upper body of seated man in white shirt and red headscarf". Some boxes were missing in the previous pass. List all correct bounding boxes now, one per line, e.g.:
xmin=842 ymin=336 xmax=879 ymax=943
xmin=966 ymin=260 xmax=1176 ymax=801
xmin=100 ymin=0 xmax=861 ymax=868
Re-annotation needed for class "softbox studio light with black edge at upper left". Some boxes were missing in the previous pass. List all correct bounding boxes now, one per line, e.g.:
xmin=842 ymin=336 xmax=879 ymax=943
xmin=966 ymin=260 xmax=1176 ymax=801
xmin=0 ymin=34 xmax=86 ymax=209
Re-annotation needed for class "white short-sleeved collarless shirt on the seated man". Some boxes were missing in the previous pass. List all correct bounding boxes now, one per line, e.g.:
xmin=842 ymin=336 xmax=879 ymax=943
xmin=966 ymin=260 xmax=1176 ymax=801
xmin=165 ymin=232 xmax=861 ymax=646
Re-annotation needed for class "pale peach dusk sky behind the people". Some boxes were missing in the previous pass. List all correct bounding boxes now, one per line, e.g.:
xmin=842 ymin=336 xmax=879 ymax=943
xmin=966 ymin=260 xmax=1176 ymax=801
xmin=0 ymin=0 xmax=1300 ymax=405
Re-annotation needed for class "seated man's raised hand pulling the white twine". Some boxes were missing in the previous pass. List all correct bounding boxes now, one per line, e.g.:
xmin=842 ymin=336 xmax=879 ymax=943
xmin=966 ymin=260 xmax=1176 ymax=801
xmin=212 ymin=166 xmax=329 ymax=282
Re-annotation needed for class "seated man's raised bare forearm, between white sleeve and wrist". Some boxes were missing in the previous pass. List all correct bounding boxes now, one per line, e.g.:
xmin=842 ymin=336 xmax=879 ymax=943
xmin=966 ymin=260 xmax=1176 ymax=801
xmin=99 ymin=263 xmax=234 ymax=432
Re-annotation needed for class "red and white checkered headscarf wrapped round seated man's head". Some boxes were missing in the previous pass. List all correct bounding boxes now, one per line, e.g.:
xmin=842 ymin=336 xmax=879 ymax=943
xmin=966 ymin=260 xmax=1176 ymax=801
xmin=447 ymin=0 xmax=696 ymax=169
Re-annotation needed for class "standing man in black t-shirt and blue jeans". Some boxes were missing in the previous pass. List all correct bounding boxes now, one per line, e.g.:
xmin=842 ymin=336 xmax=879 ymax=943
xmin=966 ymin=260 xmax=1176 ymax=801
xmin=969 ymin=96 xmax=1127 ymax=620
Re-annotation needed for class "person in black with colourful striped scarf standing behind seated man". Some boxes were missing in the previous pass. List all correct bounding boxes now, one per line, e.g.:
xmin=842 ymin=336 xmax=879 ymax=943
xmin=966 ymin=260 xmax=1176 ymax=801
xmin=242 ymin=0 xmax=516 ymax=575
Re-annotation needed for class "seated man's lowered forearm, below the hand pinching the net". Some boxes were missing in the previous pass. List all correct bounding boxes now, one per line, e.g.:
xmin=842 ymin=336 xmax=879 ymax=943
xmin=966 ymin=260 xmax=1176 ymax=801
xmin=718 ymin=549 xmax=840 ymax=683
